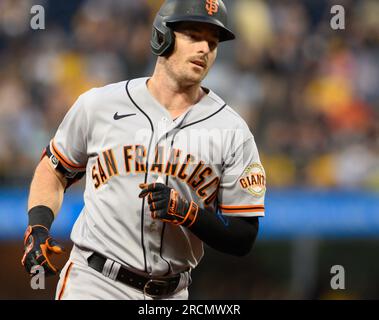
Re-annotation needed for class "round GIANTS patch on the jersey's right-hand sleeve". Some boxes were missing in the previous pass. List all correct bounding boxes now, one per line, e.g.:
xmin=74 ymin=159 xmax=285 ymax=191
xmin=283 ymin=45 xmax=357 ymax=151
xmin=239 ymin=163 xmax=266 ymax=197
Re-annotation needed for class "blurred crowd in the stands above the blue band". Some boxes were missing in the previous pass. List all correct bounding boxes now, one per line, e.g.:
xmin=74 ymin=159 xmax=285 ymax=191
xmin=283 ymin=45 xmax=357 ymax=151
xmin=0 ymin=0 xmax=379 ymax=189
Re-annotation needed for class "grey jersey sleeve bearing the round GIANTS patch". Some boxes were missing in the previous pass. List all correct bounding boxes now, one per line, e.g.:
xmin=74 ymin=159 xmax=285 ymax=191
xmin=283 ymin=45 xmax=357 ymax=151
xmin=218 ymin=135 xmax=266 ymax=217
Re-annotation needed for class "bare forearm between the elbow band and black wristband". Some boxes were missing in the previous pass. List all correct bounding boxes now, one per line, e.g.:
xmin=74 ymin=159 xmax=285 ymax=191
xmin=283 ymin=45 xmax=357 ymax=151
xmin=28 ymin=157 xmax=66 ymax=216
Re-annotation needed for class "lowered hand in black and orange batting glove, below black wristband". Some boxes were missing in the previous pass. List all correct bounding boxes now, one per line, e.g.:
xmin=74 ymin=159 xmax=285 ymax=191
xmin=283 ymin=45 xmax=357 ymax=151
xmin=21 ymin=225 xmax=64 ymax=276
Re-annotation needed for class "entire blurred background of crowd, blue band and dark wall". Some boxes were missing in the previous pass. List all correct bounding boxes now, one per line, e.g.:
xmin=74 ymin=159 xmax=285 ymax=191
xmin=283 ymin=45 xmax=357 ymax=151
xmin=0 ymin=0 xmax=379 ymax=299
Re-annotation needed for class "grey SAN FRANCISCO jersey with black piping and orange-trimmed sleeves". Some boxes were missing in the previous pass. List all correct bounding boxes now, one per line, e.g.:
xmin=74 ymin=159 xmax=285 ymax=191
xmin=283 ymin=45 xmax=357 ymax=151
xmin=50 ymin=78 xmax=266 ymax=276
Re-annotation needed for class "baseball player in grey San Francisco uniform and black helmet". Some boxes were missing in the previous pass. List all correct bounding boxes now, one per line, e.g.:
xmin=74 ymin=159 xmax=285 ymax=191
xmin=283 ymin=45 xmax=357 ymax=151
xmin=22 ymin=0 xmax=266 ymax=300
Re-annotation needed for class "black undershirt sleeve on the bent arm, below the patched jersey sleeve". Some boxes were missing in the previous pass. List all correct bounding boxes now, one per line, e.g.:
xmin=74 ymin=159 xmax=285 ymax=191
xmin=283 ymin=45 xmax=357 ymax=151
xmin=189 ymin=209 xmax=259 ymax=256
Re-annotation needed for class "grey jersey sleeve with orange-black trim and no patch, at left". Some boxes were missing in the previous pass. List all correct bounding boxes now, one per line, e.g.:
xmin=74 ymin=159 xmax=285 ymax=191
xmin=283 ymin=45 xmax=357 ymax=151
xmin=50 ymin=96 xmax=88 ymax=172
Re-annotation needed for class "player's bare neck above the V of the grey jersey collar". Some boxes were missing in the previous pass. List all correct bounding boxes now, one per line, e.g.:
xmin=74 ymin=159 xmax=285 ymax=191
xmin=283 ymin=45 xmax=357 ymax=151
xmin=147 ymin=72 xmax=205 ymax=118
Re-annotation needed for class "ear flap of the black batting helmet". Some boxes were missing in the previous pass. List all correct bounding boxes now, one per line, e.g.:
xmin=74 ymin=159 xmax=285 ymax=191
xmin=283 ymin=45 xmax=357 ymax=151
xmin=151 ymin=16 xmax=175 ymax=56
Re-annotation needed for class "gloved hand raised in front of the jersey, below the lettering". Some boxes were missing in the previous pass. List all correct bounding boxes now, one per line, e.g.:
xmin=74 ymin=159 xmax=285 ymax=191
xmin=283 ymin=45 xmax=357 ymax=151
xmin=139 ymin=183 xmax=199 ymax=227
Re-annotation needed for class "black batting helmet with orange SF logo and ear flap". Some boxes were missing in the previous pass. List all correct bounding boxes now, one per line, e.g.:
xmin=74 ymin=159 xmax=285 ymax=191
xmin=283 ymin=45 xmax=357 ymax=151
xmin=151 ymin=0 xmax=235 ymax=56
